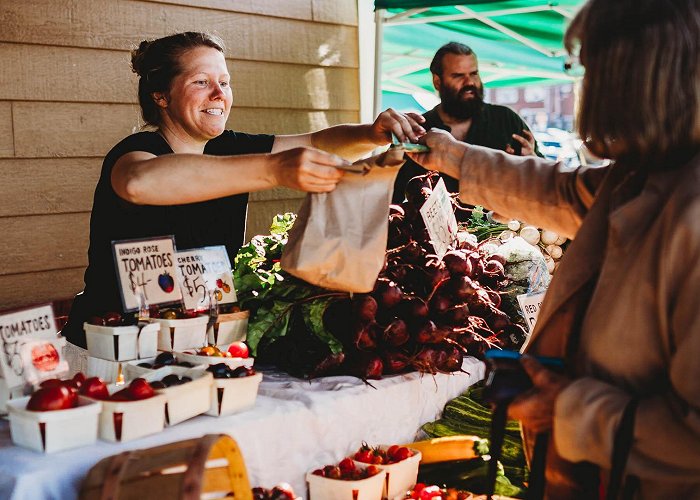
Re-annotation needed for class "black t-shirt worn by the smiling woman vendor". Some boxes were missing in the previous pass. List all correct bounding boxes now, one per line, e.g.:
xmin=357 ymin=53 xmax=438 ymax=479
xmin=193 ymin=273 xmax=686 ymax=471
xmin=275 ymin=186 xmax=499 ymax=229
xmin=63 ymin=130 xmax=274 ymax=346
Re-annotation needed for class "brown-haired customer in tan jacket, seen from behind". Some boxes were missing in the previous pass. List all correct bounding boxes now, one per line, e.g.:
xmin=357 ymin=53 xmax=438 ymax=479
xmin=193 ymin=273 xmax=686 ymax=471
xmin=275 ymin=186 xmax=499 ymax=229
xmin=414 ymin=0 xmax=700 ymax=499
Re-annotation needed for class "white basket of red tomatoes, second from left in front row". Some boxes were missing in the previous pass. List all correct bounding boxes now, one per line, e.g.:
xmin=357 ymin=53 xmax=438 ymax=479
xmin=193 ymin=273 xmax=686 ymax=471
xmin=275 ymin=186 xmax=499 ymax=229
xmin=91 ymin=386 xmax=166 ymax=443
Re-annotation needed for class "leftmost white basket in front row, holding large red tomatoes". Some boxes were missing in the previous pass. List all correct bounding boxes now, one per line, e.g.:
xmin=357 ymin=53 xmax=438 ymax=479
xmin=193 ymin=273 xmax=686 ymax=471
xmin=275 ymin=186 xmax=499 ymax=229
xmin=6 ymin=396 xmax=102 ymax=453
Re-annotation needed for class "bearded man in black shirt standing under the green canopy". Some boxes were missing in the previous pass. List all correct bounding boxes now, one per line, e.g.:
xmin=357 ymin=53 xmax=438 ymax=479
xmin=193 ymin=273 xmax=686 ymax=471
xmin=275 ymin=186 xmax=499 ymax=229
xmin=392 ymin=42 xmax=542 ymax=210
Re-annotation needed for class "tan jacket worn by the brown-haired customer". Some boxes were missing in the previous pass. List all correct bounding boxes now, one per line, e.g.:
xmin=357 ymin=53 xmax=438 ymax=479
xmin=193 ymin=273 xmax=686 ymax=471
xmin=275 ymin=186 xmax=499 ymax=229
xmin=460 ymin=146 xmax=700 ymax=499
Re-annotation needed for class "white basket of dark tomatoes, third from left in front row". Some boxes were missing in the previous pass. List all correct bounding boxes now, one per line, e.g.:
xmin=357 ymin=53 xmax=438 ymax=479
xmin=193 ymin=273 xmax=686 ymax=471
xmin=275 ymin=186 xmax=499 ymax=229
xmin=144 ymin=366 xmax=214 ymax=426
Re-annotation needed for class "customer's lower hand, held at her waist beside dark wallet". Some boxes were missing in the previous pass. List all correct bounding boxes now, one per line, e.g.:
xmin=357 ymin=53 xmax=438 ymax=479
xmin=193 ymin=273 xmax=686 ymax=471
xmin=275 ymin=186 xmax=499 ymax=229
xmin=508 ymin=356 xmax=570 ymax=434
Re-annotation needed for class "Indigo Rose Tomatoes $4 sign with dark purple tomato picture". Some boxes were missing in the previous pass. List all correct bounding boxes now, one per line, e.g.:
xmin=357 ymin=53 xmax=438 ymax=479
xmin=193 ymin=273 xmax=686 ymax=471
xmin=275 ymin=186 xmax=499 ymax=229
xmin=112 ymin=236 xmax=182 ymax=311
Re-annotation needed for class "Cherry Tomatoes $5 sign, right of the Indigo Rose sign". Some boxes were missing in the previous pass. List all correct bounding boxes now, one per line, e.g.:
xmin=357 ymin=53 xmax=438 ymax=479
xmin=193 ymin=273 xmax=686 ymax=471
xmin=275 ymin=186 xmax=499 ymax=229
xmin=175 ymin=245 xmax=237 ymax=309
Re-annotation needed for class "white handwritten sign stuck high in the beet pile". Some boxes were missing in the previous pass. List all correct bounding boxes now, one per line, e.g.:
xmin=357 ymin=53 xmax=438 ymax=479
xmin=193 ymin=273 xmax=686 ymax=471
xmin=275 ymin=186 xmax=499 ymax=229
xmin=420 ymin=179 xmax=457 ymax=257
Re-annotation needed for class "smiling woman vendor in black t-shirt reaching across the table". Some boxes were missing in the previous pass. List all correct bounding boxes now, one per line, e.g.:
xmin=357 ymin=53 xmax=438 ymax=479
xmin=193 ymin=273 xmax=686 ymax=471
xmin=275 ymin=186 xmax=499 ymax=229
xmin=63 ymin=32 xmax=424 ymax=346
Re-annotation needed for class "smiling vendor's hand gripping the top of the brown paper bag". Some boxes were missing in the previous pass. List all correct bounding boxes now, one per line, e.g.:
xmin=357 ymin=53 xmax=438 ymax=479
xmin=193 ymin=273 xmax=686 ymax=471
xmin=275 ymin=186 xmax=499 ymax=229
xmin=272 ymin=148 xmax=349 ymax=193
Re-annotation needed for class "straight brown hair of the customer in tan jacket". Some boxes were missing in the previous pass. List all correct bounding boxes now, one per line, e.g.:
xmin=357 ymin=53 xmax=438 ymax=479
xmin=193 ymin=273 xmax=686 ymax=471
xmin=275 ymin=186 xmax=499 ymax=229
xmin=565 ymin=0 xmax=700 ymax=165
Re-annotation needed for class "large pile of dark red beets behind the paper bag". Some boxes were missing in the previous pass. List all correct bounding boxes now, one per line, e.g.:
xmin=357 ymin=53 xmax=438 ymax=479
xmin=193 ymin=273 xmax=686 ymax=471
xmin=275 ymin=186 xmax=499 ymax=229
xmin=325 ymin=172 xmax=526 ymax=379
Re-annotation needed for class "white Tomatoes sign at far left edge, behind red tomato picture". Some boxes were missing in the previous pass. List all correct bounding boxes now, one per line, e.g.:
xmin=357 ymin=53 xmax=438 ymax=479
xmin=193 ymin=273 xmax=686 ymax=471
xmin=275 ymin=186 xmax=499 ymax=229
xmin=0 ymin=304 xmax=58 ymax=388
